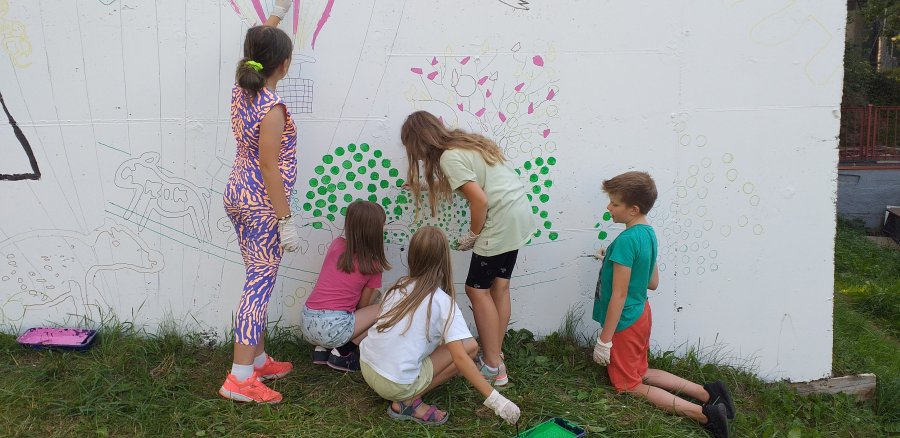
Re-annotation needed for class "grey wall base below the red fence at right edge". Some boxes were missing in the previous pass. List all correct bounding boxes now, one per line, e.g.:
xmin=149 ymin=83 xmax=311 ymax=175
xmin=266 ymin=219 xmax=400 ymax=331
xmin=837 ymin=168 xmax=900 ymax=229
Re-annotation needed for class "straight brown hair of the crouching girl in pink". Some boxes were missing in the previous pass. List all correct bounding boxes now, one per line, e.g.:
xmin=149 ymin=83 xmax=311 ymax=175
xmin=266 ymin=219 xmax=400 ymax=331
xmin=338 ymin=199 xmax=391 ymax=275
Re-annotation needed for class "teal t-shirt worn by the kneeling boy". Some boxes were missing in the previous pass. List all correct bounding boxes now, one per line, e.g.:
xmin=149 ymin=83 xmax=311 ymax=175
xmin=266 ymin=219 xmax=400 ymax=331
xmin=593 ymin=224 xmax=658 ymax=332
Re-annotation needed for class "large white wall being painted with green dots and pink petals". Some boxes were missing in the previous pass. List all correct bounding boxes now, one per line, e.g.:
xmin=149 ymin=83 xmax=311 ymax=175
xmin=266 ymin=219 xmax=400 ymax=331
xmin=0 ymin=0 xmax=845 ymax=380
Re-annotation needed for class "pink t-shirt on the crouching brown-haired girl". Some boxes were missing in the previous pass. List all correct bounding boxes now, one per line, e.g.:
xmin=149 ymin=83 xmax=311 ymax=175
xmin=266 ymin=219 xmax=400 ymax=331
xmin=306 ymin=237 xmax=381 ymax=312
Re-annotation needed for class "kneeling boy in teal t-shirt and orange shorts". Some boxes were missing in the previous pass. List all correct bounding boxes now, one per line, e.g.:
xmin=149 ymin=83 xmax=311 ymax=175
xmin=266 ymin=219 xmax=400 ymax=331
xmin=593 ymin=172 xmax=734 ymax=438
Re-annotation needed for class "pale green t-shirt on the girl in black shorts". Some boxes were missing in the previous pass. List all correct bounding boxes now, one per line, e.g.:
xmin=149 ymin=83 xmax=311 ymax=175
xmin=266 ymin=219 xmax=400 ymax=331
xmin=441 ymin=149 xmax=537 ymax=257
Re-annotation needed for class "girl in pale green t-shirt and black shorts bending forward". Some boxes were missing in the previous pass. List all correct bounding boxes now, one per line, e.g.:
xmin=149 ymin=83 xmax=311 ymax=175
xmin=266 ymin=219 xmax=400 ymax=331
xmin=400 ymin=111 xmax=537 ymax=386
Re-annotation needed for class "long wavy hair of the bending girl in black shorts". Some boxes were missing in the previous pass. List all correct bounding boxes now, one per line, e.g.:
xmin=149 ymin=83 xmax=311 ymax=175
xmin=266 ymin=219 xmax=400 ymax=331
xmin=400 ymin=111 xmax=506 ymax=216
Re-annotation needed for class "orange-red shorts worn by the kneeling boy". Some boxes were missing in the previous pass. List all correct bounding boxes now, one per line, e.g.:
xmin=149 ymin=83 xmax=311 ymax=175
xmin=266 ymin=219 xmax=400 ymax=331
xmin=606 ymin=301 xmax=653 ymax=392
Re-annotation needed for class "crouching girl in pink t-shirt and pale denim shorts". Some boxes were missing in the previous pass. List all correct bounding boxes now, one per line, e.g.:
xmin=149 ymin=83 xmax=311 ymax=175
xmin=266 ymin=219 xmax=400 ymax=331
xmin=300 ymin=200 xmax=391 ymax=371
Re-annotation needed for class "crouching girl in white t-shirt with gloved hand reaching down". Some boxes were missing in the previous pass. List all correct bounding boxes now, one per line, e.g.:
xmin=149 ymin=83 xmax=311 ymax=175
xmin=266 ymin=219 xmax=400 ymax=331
xmin=360 ymin=226 xmax=519 ymax=425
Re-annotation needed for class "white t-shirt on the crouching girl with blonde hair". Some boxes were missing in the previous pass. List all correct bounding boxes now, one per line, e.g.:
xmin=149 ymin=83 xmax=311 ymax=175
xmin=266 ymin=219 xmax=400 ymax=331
xmin=359 ymin=284 xmax=472 ymax=385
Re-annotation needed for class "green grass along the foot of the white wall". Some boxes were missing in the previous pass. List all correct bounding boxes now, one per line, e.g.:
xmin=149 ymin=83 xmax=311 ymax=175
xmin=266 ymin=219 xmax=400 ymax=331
xmin=0 ymin=222 xmax=900 ymax=437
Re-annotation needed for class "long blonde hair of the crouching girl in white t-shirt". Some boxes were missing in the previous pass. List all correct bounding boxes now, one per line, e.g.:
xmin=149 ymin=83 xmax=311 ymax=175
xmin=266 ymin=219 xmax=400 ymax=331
xmin=375 ymin=226 xmax=456 ymax=336
